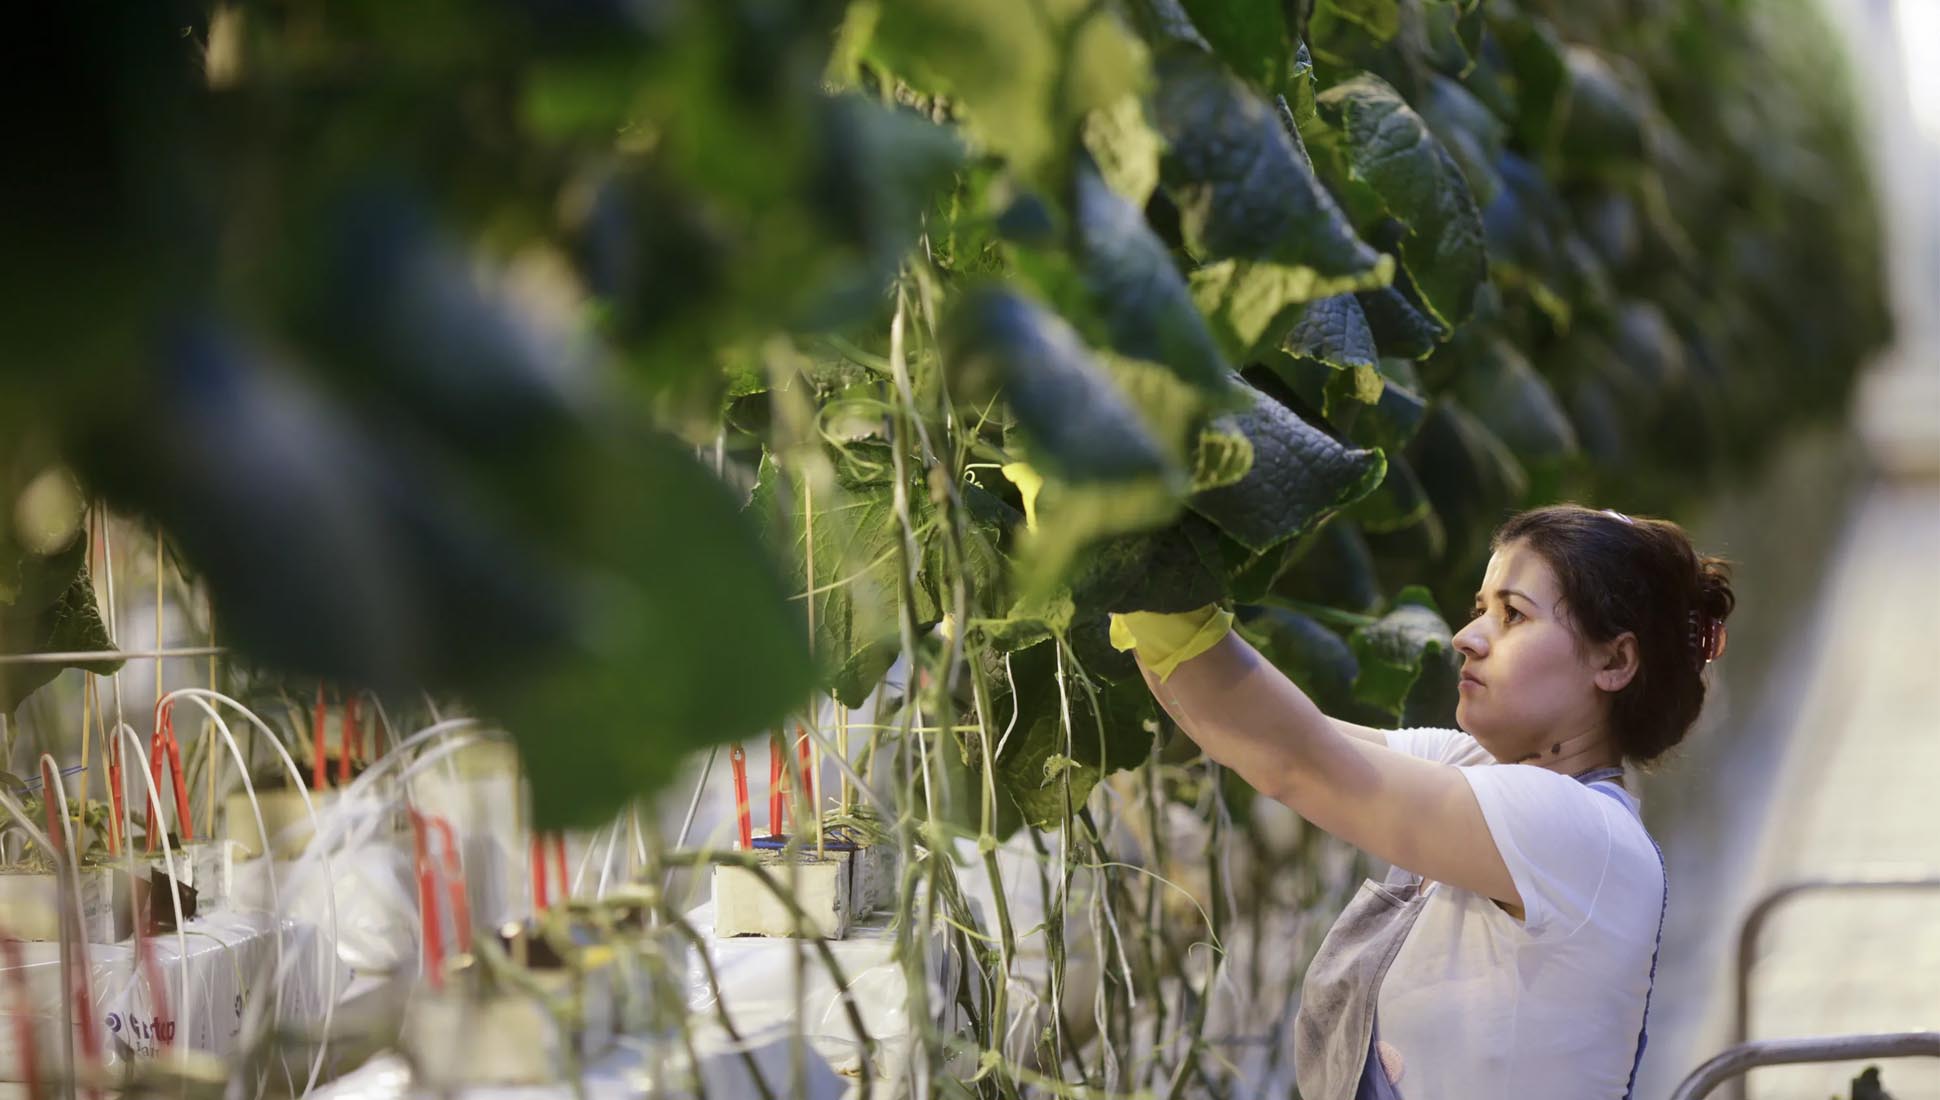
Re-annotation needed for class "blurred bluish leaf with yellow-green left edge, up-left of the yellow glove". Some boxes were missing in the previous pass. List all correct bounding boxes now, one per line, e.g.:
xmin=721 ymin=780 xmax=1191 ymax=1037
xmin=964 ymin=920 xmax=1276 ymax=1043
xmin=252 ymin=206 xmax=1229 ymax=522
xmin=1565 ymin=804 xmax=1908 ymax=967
xmin=943 ymin=289 xmax=1168 ymax=483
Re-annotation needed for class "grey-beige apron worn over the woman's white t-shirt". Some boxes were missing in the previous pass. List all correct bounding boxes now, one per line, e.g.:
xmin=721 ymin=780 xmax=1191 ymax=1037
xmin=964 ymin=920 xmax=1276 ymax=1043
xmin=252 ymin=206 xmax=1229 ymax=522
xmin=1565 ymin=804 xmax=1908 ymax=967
xmin=1294 ymin=768 xmax=1668 ymax=1100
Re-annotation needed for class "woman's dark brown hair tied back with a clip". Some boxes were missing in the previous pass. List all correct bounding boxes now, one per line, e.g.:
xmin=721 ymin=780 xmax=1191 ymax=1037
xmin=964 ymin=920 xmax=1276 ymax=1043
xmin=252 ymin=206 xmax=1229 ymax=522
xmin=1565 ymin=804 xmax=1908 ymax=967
xmin=1490 ymin=504 xmax=1736 ymax=764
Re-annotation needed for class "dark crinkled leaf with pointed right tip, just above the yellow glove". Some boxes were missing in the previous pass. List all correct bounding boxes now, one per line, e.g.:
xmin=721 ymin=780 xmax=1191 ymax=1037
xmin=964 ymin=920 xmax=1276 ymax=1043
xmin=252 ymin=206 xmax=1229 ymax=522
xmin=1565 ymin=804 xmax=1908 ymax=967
xmin=1191 ymin=380 xmax=1387 ymax=553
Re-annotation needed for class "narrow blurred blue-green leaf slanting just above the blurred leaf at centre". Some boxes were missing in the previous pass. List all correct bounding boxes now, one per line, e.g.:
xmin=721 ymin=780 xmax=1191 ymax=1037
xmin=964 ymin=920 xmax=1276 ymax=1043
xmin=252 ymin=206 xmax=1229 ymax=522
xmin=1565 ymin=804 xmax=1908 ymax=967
xmin=1073 ymin=159 xmax=1226 ymax=392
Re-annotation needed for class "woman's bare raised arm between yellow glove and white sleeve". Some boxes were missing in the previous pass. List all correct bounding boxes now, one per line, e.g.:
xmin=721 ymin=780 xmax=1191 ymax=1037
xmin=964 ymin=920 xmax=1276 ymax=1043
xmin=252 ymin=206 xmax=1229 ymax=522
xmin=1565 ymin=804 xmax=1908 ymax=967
xmin=1139 ymin=631 xmax=1521 ymax=906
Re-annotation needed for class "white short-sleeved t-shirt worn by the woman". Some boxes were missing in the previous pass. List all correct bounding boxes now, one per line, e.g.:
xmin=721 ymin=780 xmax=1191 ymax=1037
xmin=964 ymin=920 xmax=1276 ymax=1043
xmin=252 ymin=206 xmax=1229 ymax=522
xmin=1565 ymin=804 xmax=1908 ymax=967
xmin=1377 ymin=729 xmax=1665 ymax=1100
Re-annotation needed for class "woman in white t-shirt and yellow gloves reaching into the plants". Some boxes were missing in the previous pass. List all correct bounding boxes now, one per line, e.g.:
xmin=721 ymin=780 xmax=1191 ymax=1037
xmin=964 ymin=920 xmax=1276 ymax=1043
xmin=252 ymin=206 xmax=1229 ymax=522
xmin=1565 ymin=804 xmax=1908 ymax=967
xmin=1112 ymin=504 xmax=1734 ymax=1100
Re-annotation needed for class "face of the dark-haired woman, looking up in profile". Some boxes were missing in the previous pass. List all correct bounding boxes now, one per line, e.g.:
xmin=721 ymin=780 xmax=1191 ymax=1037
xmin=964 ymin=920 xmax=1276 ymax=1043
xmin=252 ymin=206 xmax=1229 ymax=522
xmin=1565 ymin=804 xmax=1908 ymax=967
xmin=1455 ymin=539 xmax=1622 ymax=760
